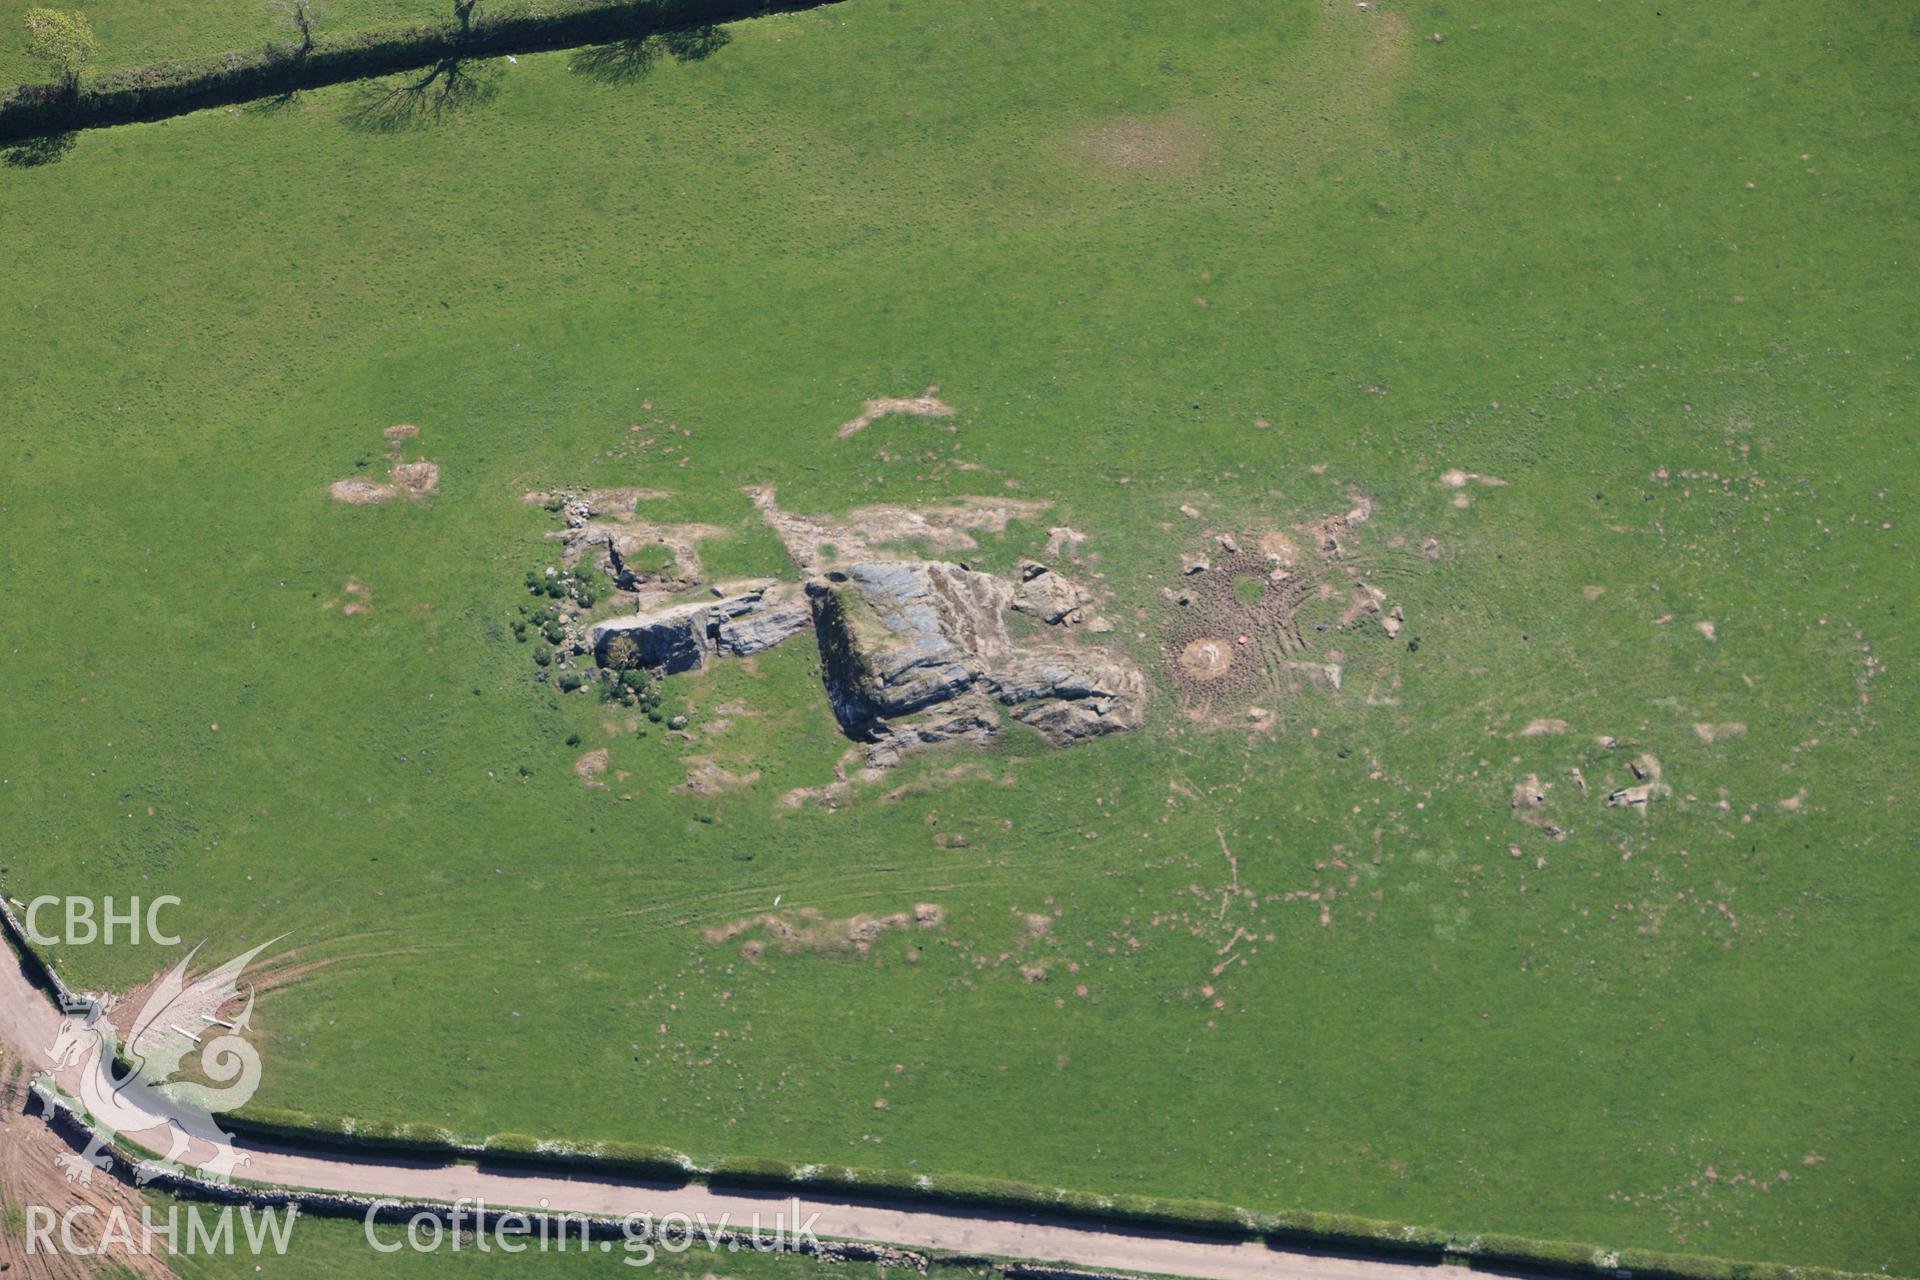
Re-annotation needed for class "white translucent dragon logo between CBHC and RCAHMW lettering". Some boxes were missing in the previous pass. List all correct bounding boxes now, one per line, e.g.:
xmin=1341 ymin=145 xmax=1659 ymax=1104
xmin=52 ymin=938 xmax=278 ymax=1186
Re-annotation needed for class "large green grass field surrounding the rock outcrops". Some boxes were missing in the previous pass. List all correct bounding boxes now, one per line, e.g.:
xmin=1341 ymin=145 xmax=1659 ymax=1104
xmin=0 ymin=0 xmax=1920 ymax=1274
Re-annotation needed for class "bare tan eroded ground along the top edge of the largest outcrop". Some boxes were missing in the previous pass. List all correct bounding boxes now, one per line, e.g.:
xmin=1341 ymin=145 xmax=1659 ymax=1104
xmin=747 ymin=487 xmax=1071 ymax=576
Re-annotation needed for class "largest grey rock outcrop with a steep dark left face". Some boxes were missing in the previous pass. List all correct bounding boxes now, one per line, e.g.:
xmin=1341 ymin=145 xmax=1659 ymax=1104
xmin=806 ymin=560 xmax=1146 ymax=756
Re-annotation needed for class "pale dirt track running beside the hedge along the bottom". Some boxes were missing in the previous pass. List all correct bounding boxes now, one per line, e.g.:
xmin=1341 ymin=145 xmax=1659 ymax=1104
xmin=0 ymin=944 xmax=1434 ymax=1280
